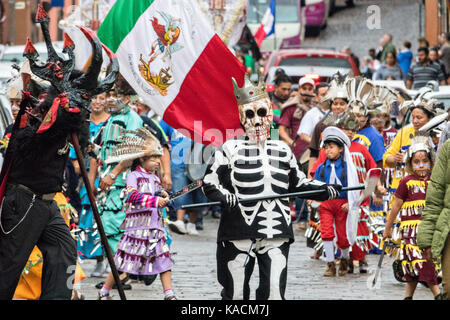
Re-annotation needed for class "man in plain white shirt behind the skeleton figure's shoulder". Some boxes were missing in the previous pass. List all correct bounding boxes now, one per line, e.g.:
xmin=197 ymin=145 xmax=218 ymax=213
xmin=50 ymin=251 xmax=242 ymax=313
xmin=297 ymin=82 xmax=328 ymax=144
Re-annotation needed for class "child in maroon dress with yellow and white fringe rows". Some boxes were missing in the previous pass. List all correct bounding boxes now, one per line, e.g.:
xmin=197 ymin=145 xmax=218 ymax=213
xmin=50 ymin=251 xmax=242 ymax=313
xmin=383 ymin=135 xmax=442 ymax=300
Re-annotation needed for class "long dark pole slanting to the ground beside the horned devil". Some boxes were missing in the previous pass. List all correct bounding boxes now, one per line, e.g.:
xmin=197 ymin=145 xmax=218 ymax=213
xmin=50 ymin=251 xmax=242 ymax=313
xmin=71 ymin=133 xmax=127 ymax=300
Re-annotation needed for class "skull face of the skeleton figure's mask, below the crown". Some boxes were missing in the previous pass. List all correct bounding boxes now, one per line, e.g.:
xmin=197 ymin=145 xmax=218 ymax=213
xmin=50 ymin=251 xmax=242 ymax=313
xmin=239 ymin=98 xmax=273 ymax=141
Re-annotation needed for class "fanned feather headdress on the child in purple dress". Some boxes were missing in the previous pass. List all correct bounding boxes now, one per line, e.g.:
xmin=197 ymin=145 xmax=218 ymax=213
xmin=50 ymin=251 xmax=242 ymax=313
xmin=105 ymin=128 xmax=163 ymax=164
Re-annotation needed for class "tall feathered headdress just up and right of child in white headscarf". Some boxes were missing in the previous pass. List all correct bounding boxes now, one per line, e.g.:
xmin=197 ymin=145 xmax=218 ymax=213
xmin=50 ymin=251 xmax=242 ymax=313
xmin=346 ymin=77 xmax=375 ymax=115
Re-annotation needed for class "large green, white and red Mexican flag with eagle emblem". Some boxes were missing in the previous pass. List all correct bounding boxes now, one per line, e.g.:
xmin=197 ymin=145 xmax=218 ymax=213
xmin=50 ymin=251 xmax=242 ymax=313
xmin=97 ymin=0 xmax=245 ymax=146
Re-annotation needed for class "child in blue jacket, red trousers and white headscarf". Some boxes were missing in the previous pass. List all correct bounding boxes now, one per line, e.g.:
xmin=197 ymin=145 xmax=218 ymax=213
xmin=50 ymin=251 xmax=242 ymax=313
xmin=314 ymin=127 xmax=359 ymax=277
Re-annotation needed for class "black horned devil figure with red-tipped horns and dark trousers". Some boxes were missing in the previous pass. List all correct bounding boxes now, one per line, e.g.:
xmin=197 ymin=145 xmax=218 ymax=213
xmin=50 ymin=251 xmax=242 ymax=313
xmin=0 ymin=6 xmax=118 ymax=299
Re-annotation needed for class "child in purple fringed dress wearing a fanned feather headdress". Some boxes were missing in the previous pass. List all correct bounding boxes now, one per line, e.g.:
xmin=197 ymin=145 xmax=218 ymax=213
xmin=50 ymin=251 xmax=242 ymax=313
xmin=99 ymin=128 xmax=176 ymax=300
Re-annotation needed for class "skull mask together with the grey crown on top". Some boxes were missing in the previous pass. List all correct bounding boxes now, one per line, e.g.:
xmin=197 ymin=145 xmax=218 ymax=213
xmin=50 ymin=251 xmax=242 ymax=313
xmin=232 ymin=75 xmax=273 ymax=141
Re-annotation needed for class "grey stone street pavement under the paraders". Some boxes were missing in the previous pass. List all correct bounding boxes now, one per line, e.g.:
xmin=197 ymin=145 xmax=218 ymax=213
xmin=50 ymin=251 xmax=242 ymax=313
xmin=76 ymin=216 xmax=432 ymax=300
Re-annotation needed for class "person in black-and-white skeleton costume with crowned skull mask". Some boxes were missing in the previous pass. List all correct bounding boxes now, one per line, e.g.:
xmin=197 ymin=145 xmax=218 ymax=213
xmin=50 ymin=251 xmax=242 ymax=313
xmin=203 ymin=76 xmax=341 ymax=300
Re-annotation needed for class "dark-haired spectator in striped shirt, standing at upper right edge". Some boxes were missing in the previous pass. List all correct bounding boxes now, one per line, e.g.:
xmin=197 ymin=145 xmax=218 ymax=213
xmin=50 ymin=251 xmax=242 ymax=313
xmin=406 ymin=47 xmax=446 ymax=90
